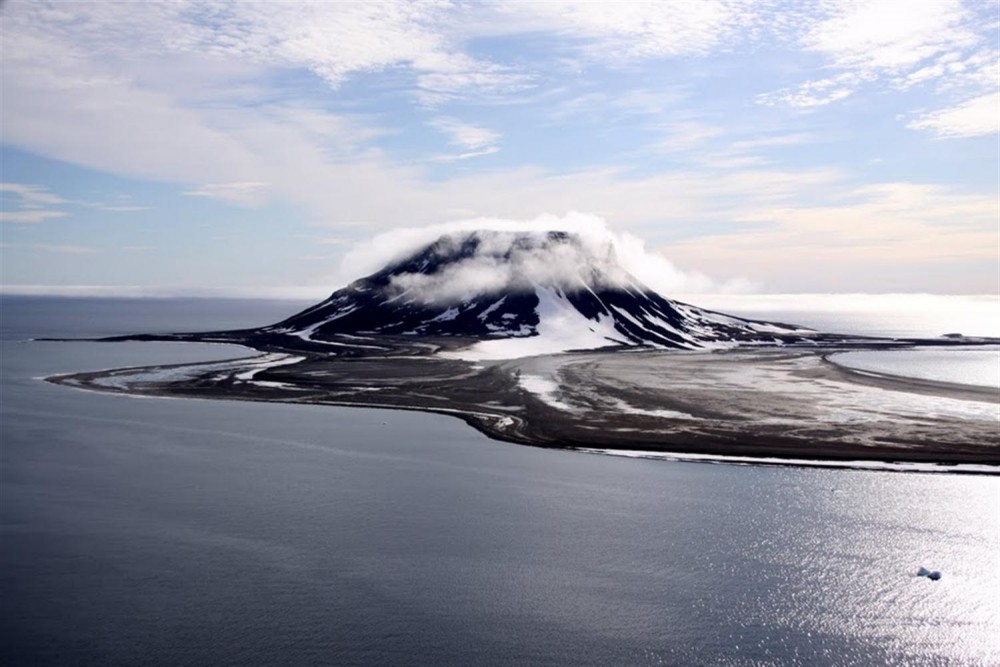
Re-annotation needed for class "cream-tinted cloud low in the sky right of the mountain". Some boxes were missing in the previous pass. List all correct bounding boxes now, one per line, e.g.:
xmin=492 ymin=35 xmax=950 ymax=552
xmin=663 ymin=183 xmax=1000 ymax=293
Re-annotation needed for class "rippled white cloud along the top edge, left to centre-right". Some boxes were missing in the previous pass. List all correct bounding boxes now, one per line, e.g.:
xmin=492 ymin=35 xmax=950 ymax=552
xmin=0 ymin=0 xmax=749 ymax=103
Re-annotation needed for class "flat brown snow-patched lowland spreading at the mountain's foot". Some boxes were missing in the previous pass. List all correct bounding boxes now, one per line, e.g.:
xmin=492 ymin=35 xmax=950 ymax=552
xmin=46 ymin=341 xmax=1000 ymax=474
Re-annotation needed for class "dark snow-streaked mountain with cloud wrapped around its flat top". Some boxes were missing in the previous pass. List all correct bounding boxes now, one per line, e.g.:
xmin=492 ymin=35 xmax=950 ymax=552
xmin=261 ymin=231 xmax=812 ymax=356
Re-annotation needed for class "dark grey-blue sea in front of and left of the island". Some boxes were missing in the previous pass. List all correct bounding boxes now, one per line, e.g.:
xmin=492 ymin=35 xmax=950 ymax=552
xmin=0 ymin=299 xmax=1000 ymax=665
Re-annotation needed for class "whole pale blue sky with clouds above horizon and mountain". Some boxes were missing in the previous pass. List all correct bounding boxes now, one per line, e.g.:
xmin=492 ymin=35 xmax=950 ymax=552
xmin=0 ymin=0 xmax=1000 ymax=296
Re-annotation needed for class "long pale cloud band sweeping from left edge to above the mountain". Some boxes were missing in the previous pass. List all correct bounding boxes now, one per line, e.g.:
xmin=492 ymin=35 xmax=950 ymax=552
xmin=3 ymin=9 xmax=860 ymax=235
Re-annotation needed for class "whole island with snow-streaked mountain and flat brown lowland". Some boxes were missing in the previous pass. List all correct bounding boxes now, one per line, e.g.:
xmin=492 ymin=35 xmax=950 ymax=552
xmin=49 ymin=231 xmax=1000 ymax=472
